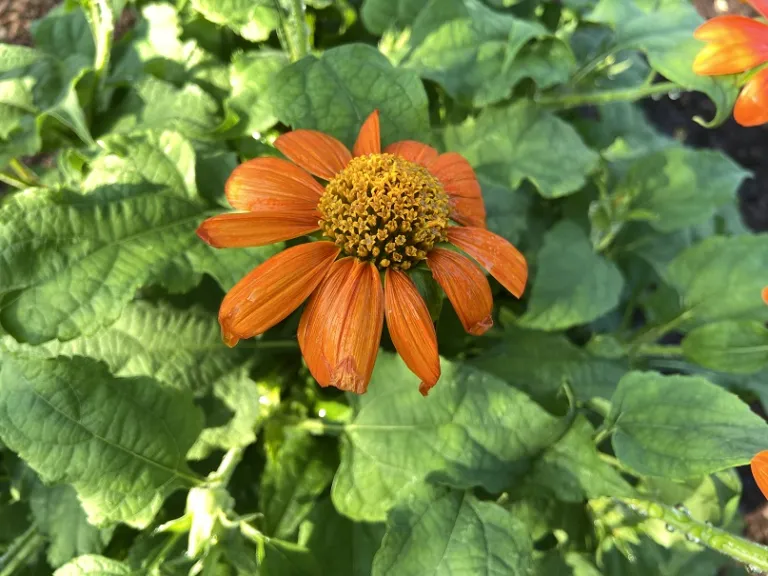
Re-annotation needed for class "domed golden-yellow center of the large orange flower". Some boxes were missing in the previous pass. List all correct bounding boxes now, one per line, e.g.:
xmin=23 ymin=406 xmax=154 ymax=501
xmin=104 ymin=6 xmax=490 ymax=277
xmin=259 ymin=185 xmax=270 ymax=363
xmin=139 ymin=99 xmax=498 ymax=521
xmin=318 ymin=154 xmax=449 ymax=270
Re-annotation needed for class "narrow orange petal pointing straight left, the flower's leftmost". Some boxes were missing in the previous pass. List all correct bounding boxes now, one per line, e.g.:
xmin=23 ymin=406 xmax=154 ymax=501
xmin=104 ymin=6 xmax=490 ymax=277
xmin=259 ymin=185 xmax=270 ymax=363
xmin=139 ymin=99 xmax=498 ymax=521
xmin=197 ymin=210 xmax=320 ymax=248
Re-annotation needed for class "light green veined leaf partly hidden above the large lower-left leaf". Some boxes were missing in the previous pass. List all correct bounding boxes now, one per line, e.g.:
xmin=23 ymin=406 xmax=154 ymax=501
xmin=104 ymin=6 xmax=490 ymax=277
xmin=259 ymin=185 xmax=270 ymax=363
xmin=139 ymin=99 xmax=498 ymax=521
xmin=0 ymin=302 xmax=246 ymax=394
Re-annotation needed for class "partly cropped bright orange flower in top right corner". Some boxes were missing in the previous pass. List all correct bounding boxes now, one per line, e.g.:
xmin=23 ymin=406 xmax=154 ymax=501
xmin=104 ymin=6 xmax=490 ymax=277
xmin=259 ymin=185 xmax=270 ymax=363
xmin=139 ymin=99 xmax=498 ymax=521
xmin=693 ymin=0 xmax=768 ymax=126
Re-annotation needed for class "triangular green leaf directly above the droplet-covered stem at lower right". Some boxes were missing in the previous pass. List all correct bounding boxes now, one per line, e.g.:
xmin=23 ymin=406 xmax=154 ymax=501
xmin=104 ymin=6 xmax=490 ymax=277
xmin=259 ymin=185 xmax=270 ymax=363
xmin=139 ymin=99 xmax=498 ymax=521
xmin=526 ymin=416 xmax=636 ymax=502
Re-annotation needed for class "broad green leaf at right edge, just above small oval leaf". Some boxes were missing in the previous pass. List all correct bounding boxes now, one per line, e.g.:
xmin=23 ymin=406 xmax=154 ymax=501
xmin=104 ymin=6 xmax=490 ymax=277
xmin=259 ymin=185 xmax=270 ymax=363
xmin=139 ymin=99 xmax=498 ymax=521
xmin=665 ymin=234 xmax=768 ymax=322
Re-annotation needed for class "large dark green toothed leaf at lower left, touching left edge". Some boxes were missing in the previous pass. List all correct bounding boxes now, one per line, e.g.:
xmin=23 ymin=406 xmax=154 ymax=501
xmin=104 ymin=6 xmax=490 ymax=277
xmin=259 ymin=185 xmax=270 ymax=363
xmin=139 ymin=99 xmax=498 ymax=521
xmin=0 ymin=353 xmax=202 ymax=528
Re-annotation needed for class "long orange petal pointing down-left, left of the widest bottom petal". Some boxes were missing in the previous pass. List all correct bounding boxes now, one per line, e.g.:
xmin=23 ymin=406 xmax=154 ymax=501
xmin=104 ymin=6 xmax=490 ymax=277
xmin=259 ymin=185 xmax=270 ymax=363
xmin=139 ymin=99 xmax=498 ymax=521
xmin=219 ymin=242 xmax=340 ymax=346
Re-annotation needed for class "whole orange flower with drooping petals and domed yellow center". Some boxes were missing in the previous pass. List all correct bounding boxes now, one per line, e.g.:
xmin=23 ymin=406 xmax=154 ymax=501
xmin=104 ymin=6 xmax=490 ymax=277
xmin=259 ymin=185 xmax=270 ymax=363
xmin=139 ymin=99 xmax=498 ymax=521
xmin=197 ymin=112 xmax=527 ymax=394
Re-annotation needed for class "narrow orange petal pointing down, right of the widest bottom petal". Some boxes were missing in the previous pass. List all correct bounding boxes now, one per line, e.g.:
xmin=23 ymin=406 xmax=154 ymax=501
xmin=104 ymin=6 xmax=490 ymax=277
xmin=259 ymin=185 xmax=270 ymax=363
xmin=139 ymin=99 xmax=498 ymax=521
xmin=384 ymin=268 xmax=440 ymax=396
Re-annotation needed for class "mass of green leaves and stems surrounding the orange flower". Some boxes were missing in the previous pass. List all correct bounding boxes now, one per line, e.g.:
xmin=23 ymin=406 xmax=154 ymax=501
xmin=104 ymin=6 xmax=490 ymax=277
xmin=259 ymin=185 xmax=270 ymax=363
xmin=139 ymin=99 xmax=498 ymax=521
xmin=0 ymin=0 xmax=768 ymax=576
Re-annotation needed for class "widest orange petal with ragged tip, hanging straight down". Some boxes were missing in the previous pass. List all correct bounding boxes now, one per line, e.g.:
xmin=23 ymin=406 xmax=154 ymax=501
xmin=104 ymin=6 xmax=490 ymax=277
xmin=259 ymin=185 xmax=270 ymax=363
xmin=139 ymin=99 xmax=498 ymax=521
xmin=299 ymin=258 xmax=384 ymax=394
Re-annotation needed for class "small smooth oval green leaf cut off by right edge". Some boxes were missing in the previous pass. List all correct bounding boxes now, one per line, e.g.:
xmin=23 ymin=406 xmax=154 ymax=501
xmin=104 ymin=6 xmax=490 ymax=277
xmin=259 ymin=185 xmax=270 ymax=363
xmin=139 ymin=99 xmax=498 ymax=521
xmin=682 ymin=320 xmax=768 ymax=374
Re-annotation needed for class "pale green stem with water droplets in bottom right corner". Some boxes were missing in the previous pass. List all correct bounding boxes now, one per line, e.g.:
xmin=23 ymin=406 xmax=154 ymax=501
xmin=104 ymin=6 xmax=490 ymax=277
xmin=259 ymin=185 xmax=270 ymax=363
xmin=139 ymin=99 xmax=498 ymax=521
xmin=616 ymin=498 xmax=768 ymax=572
